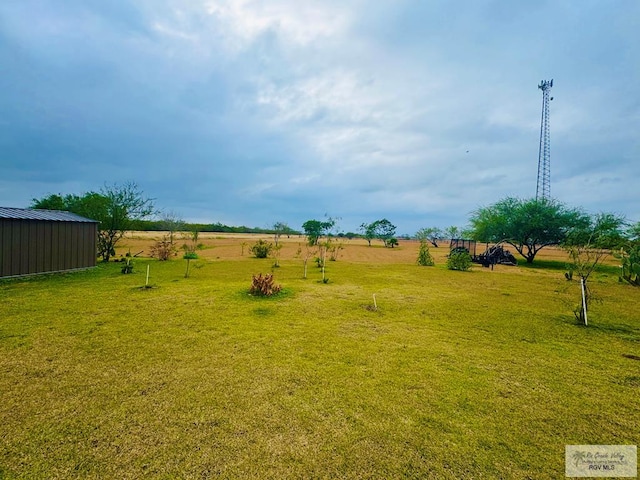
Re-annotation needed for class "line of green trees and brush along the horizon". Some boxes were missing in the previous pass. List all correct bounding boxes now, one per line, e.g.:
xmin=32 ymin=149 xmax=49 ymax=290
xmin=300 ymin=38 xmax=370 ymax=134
xmin=30 ymin=182 xmax=640 ymax=279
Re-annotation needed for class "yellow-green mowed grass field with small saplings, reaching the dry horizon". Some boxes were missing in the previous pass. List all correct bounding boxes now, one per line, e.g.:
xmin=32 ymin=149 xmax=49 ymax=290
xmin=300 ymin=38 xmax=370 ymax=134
xmin=0 ymin=233 xmax=640 ymax=479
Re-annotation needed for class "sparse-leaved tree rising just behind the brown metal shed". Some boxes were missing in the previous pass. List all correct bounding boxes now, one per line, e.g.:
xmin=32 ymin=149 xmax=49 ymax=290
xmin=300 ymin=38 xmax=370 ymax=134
xmin=31 ymin=182 xmax=154 ymax=262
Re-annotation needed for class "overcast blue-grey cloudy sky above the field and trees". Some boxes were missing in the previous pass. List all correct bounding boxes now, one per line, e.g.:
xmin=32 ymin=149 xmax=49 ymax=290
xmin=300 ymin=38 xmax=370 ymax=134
xmin=0 ymin=0 xmax=640 ymax=234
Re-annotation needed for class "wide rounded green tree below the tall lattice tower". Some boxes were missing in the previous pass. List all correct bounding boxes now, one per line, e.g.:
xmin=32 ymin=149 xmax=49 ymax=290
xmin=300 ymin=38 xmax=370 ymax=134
xmin=470 ymin=197 xmax=589 ymax=263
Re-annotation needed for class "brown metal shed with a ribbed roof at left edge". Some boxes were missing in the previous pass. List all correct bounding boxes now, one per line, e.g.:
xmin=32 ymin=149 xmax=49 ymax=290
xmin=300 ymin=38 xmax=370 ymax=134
xmin=0 ymin=207 xmax=98 ymax=278
